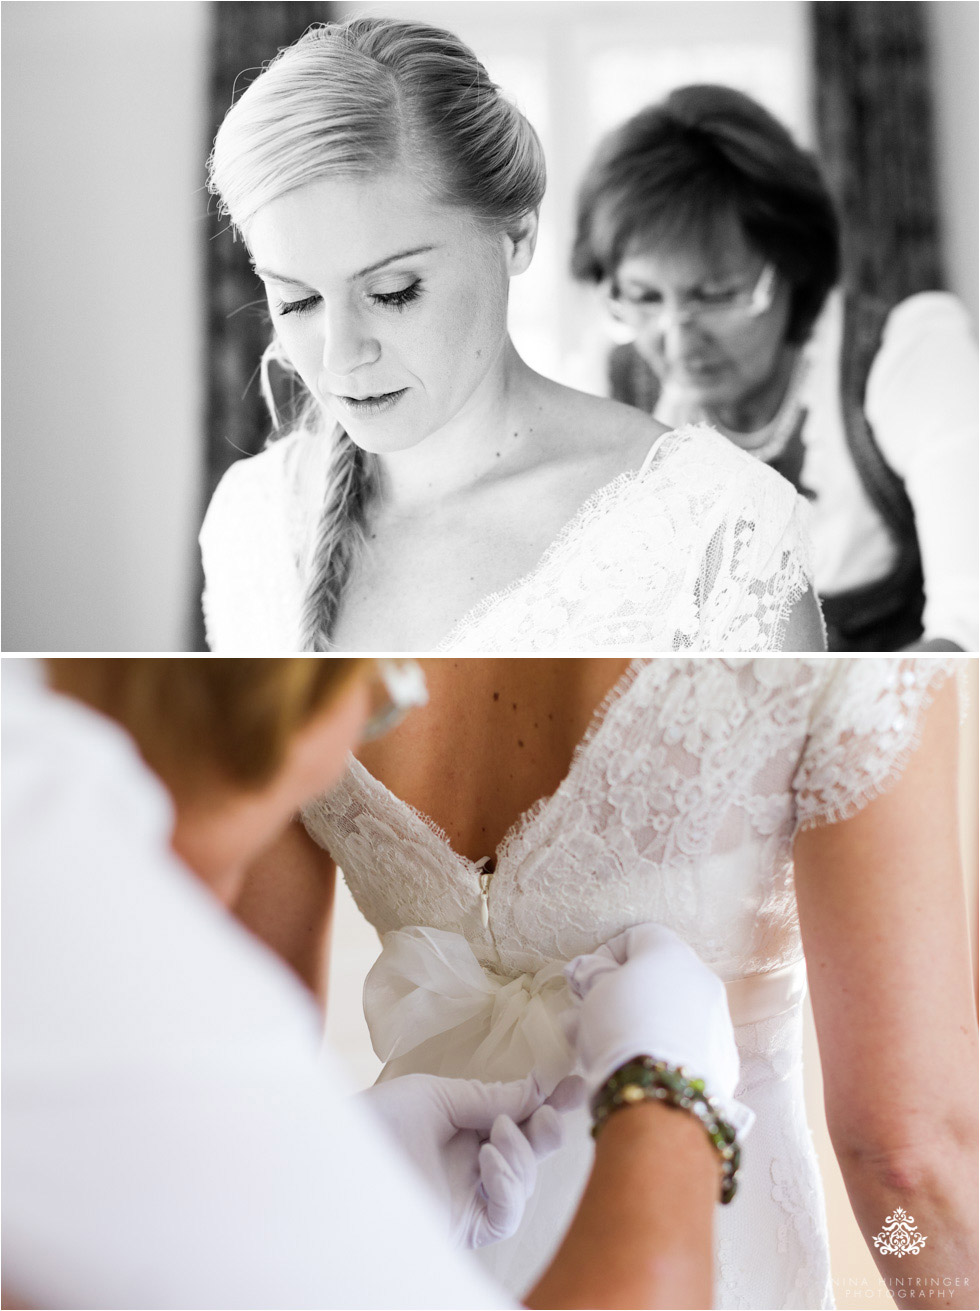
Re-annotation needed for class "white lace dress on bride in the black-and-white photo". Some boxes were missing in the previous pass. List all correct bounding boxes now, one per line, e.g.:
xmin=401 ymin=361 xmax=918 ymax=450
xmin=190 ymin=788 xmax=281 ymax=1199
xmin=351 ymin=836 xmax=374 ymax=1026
xmin=200 ymin=426 xmax=812 ymax=654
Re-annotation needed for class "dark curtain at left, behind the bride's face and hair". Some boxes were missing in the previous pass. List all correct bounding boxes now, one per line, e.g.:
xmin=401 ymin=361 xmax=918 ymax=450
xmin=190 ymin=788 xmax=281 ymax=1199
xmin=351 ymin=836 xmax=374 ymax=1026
xmin=193 ymin=0 xmax=338 ymax=650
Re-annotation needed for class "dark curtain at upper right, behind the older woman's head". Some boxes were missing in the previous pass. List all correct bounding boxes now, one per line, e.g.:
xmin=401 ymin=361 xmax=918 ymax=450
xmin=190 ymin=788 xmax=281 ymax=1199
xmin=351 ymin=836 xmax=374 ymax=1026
xmin=810 ymin=0 xmax=943 ymax=304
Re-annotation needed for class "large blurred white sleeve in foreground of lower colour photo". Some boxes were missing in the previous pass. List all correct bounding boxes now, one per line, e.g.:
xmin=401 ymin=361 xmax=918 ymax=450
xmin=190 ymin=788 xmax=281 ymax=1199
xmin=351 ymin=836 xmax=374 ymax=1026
xmin=3 ymin=669 xmax=512 ymax=1308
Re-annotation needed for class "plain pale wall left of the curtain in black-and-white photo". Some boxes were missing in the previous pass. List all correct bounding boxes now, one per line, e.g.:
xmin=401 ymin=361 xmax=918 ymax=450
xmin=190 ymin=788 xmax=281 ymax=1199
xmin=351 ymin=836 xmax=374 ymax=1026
xmin=3 ymin=0 xmax=208 ymax=652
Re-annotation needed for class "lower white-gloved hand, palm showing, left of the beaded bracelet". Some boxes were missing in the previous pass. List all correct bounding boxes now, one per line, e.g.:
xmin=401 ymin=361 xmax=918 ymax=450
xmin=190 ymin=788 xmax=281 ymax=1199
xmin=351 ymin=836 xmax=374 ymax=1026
xmin=359 ymin=1074 xmax=583 ymax=1247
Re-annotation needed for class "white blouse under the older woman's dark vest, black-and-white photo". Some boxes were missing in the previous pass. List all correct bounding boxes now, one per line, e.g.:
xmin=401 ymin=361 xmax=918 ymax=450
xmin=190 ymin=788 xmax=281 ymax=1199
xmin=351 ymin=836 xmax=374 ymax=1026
xmin=654 ymin=291 xmax=980 ymax=650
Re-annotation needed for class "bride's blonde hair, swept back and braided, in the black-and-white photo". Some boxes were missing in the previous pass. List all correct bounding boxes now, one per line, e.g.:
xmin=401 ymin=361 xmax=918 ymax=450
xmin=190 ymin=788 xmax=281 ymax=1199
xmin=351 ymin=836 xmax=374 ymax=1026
xmin=208 ymin=18 xmax=545 ymax=650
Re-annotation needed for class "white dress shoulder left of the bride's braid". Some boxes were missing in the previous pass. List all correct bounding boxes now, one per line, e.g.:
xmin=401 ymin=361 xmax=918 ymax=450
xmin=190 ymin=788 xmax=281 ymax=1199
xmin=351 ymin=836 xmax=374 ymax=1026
xmin=199 ymin=442 xmax=300 ymax=654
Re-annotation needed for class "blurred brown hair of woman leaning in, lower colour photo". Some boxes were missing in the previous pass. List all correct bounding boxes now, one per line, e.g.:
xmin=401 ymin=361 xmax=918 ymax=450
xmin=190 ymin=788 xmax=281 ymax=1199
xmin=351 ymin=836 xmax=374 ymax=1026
xmin=47 ymin=657 xmax=369 ymax=800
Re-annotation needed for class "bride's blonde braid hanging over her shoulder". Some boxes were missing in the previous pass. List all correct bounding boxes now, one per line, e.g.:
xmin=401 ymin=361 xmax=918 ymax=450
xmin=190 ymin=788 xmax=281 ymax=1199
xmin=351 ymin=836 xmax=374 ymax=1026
xmin=300 ymin=429 xmax=376 ymax=652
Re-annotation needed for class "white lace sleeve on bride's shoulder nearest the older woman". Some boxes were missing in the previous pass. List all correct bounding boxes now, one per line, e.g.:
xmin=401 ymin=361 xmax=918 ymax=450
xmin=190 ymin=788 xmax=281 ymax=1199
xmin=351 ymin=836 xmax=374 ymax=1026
xmin=698 ymin=437 xmax=814 ymax=652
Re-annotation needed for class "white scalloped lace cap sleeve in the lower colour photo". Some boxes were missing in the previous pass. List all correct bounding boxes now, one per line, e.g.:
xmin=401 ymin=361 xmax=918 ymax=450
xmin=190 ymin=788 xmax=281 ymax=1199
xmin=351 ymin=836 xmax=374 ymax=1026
xmin=793 ymin=657 xmax=956 ymax=829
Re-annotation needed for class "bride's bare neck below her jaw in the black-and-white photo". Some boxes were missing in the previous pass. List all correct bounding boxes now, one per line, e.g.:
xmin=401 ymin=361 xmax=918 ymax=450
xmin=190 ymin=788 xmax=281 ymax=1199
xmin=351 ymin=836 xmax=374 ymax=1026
xmin=379 ymin=337 xmax=546 ymax=513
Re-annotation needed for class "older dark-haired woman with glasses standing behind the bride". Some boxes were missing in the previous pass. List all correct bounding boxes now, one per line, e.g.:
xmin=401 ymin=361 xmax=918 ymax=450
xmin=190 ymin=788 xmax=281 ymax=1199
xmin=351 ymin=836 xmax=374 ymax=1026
xmin=573 ymin=87 xmax=977 ymax=650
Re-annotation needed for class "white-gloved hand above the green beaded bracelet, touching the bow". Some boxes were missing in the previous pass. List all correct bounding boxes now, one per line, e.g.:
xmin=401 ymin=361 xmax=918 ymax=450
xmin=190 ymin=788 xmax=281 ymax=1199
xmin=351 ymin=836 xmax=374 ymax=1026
xmin=565 ymin=924 xmax=755 ymax=1137
